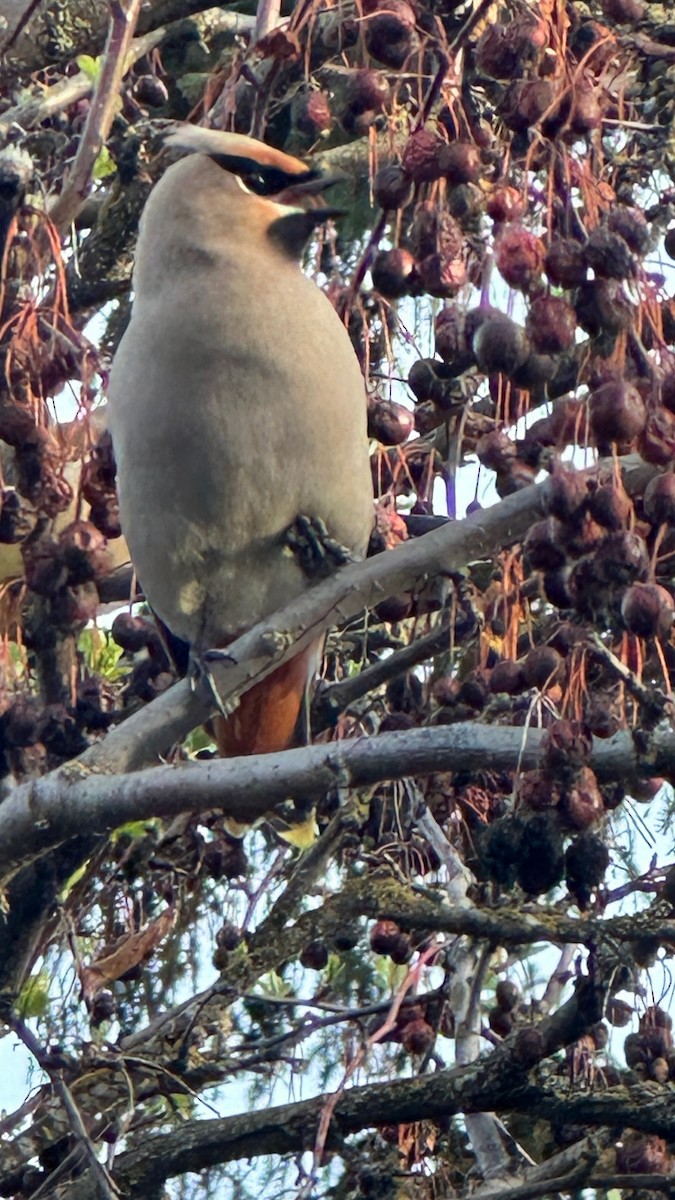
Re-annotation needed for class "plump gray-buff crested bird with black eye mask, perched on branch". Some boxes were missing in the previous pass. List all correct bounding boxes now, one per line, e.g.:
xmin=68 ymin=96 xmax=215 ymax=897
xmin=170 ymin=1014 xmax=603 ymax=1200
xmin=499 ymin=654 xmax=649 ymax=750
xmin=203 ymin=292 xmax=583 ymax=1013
xmin=109 ymin=126 xmax=372 ymax=754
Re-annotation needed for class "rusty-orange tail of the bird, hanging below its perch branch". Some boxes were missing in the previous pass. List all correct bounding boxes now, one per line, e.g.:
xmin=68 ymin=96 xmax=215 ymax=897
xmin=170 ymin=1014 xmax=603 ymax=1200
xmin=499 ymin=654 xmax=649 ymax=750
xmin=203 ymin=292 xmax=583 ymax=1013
xmin=213 ymin=640 xmax=323 ymax=758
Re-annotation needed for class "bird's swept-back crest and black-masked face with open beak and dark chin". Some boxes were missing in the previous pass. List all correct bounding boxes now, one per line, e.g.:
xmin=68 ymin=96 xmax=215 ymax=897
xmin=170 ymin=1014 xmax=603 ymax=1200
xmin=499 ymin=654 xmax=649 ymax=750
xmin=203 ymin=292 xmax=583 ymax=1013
xmin=165 ymin=125 xmax=342 ymax=257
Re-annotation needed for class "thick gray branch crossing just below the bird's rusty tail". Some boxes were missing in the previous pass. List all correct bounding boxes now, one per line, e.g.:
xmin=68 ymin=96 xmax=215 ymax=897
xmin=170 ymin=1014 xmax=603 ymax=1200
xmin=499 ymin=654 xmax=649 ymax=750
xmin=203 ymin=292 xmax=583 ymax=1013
xmin=0 ymin=724 xmax=675 ymax=877
